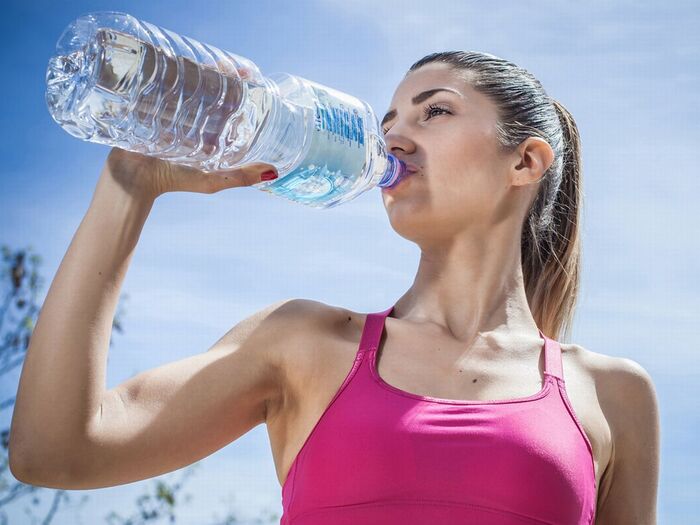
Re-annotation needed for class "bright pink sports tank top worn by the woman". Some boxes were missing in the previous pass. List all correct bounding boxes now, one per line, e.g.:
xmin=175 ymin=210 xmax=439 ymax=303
xmin=280 ymin=306 xmax=597 ymax=525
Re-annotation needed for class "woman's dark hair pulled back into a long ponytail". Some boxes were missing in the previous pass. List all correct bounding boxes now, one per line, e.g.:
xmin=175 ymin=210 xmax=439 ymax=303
xmin=406 ymin=51 xmax=583 ymax=342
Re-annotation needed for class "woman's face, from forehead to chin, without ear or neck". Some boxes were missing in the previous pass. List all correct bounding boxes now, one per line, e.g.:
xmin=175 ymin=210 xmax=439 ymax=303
xmin=382 ymin=63 xmax=514 ymax=242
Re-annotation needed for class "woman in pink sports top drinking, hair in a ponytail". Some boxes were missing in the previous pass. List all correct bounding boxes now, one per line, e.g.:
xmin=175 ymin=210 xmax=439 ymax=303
xmin=10 ymin=52 xmax=659 ymax=525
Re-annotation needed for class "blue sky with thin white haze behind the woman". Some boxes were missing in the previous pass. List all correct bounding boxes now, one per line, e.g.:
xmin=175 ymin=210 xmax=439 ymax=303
xmin=0 ymin=0 xmax=700 ymax=525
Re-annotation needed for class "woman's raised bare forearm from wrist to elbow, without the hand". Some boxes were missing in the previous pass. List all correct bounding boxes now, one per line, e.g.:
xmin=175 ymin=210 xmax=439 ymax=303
xmin=9 ymin=165 xmax=154 ymax=479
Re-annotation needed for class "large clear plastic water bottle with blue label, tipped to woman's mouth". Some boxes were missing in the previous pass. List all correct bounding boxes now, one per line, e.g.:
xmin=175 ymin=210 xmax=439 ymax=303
xmin=46 ymin=12 xmax=407 ymax=208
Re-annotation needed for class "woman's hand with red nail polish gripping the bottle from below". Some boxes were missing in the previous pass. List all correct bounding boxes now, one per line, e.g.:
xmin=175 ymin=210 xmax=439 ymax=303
xmin=103 ymin=148 xmax=276 ymax=199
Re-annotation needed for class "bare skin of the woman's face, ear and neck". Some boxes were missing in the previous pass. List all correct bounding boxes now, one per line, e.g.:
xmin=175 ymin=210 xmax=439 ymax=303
xmin=382 ymin=64 xmax=554 ymax=352
